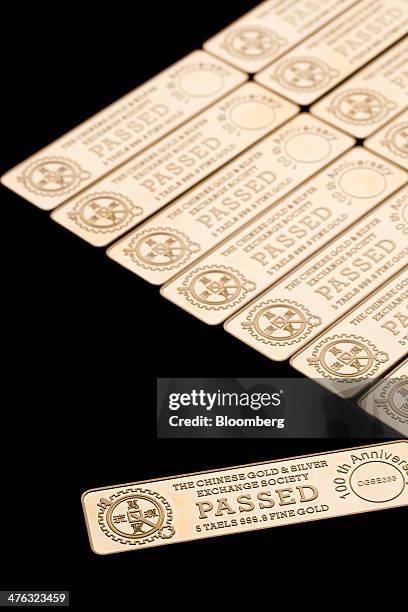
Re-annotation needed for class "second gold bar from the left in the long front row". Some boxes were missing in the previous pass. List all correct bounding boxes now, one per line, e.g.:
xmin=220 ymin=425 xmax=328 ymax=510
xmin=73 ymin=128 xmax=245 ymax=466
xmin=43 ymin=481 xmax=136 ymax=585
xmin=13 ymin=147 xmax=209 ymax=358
xmin=52 ymin=82 xmax=299 ymax=246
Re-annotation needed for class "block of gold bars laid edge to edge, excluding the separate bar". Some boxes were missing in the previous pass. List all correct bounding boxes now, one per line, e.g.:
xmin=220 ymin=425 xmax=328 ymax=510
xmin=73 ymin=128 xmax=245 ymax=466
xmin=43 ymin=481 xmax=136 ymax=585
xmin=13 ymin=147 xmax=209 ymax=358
xmin=2 ymin=0 xmax=408 ymax=435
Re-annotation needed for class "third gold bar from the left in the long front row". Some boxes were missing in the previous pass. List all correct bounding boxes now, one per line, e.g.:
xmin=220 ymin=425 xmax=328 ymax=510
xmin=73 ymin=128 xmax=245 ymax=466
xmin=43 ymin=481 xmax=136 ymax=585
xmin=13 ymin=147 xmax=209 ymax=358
xmin=108 ymin=113 xmax=354 ymax=285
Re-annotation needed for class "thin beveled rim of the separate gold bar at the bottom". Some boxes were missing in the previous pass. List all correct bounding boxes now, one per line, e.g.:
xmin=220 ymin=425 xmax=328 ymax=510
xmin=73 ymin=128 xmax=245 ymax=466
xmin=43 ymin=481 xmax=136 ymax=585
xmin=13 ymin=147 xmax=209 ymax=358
xmin=81 ymin=438 xmax=408 ymax=557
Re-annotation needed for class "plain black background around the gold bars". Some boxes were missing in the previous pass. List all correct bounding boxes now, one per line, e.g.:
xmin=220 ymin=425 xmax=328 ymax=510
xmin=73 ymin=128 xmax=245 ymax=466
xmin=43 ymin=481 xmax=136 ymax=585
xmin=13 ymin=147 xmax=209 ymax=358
xmin=0 ymin=1 xmax=404 ymax=607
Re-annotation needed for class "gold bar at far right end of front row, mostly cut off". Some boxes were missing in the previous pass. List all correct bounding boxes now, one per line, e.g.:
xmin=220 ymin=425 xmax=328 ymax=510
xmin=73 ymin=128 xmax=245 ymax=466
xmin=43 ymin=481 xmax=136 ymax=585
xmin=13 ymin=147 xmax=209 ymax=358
xmin=358 ymin=360 xmax=408 ymax=437
